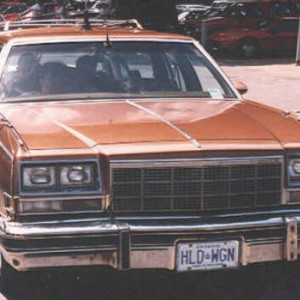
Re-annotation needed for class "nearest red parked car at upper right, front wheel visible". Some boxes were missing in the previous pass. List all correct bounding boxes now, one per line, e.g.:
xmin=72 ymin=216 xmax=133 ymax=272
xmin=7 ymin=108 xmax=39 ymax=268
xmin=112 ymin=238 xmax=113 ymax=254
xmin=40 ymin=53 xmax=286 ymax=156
xmin=208 ymin=17 xmax=299 ymax=58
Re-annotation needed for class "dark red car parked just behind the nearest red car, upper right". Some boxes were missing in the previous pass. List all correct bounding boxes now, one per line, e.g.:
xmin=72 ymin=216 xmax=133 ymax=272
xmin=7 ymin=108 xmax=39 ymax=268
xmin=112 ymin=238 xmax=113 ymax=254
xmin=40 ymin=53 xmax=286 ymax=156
xmin=184 ymin=0 xmax=300 ymax=40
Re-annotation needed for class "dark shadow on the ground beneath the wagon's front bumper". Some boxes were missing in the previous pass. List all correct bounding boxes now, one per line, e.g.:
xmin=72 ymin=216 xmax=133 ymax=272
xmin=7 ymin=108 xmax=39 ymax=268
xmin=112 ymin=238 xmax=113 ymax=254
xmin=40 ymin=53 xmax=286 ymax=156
xmin=6 ymin=263 xmax=300 ymax=300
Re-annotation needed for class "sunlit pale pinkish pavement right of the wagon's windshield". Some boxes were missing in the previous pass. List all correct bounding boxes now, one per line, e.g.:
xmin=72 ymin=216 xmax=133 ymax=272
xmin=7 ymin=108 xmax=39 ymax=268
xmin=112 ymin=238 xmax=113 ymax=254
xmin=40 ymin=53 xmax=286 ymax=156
xmin=216 ymin=58 xmax=300 ymax=111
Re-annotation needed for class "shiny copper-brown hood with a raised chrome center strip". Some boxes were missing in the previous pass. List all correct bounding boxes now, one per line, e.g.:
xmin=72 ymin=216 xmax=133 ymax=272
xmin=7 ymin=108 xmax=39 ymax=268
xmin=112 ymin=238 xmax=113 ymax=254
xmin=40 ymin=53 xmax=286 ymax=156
xmin=1 ymin=99 xmax=300 ymax=153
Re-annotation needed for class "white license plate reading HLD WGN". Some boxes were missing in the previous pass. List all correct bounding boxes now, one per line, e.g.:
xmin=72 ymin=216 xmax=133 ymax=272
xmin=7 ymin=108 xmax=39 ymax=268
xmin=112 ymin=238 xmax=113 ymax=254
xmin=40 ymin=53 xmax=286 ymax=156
xmin=177 ymin=241 xmax=239 ymax=271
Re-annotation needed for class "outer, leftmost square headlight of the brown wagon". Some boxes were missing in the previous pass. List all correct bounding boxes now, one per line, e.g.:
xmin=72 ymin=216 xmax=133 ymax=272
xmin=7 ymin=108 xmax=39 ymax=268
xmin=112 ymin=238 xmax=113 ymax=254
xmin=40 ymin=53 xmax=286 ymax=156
xmin=23 ymin=166 xmax=56 ymax=189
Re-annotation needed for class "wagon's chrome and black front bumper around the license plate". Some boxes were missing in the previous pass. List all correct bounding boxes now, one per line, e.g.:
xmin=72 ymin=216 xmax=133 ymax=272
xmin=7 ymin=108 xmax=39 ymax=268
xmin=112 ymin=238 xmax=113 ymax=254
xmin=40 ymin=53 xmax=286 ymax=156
xmin=0 ymin=211 xmax=300 ymax=270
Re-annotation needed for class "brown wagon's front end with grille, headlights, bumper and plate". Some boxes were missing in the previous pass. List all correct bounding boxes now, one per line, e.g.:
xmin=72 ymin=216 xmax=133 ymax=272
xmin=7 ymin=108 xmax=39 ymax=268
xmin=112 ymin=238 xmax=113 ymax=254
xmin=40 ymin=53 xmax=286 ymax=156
xmin=0 ymin=149 xmax=300 ymax=271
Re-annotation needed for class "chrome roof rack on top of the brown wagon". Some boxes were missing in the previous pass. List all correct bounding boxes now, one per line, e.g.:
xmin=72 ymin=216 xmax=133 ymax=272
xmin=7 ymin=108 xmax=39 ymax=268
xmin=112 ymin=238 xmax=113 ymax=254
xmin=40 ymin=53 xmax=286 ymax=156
xmin=0 ymin=19 xmax=143 ymax=31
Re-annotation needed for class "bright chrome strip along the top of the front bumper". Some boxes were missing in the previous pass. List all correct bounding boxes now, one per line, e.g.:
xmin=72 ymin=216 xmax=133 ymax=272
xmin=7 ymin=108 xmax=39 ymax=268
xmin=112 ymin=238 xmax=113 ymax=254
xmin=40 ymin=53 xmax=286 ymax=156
xmin=0 ymin=215 xmax=290 ymax=239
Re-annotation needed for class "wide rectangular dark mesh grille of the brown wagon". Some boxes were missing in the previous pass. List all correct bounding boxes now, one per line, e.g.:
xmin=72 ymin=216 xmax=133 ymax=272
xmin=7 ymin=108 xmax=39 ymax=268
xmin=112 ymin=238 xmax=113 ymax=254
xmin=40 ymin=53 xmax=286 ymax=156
xmin=112 ymin=158 xmax=282 ymax=211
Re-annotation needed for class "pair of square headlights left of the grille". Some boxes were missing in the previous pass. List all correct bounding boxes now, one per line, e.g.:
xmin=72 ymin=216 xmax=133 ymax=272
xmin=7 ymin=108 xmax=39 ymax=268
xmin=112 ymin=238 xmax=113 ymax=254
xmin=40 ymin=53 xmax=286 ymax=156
xmin=20 ymin=161 xmax=101 ymax=194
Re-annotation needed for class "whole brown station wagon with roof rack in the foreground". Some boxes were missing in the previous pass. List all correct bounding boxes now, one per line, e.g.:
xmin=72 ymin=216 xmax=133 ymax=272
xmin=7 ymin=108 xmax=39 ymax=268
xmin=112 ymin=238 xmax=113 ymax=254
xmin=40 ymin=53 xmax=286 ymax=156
xmin=0 ymin=20 xmax=300 ymax=290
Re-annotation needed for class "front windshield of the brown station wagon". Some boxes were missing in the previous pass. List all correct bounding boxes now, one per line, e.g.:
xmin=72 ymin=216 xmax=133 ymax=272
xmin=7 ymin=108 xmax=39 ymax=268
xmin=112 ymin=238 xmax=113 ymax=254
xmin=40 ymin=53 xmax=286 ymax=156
xmin=0 ymin=41 xmax=236 ymax=101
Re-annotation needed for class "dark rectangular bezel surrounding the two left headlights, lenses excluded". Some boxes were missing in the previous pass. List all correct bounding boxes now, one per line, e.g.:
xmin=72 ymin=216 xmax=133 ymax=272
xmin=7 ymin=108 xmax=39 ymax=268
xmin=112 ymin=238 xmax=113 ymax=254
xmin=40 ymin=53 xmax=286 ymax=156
xmin=19 ymin=159 xmax=102 ymax=195
